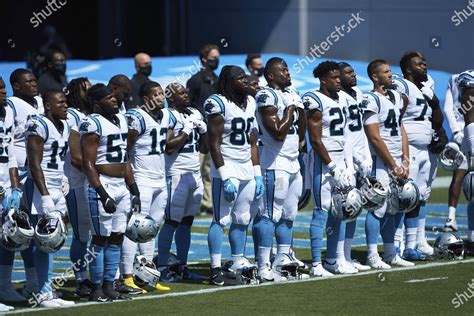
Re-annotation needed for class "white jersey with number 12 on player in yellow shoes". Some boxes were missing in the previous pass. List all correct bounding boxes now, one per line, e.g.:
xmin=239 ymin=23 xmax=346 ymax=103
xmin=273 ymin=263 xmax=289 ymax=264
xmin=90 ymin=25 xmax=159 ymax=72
xmin=126 ymin=108 xmax=171 ymax=185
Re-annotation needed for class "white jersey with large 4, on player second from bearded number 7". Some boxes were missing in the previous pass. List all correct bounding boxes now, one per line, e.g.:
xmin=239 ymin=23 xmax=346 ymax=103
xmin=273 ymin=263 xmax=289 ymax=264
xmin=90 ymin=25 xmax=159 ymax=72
xmin=364 ymin=90 xmax=403 ymax=158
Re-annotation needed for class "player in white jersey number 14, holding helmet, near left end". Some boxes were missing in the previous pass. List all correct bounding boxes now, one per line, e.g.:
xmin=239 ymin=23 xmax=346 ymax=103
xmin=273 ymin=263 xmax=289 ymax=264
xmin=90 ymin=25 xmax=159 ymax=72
xmin=25 ymin=90 xmax=74 ymax=307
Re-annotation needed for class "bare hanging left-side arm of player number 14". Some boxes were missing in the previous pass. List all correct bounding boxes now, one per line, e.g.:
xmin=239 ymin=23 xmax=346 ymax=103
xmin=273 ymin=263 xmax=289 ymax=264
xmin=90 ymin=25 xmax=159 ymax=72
xmin=26 ymin=135 xmax=49 ymax=195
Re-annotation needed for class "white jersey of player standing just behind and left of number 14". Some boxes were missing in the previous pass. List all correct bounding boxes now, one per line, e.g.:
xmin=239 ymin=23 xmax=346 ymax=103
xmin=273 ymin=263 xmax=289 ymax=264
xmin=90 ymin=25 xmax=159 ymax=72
xmin=7 ymin=96 xmax=44 ymax=168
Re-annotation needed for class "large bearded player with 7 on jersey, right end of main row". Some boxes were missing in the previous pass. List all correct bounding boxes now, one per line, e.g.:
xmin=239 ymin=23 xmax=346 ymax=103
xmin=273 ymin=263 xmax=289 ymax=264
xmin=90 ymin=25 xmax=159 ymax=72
xmin=393 ymin=52 xmax=446 ymax=260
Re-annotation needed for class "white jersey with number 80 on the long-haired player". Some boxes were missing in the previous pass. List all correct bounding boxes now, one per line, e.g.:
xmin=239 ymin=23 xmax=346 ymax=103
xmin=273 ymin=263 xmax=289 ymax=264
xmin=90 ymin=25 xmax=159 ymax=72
xmin=204 ymin=94 xmax=257 ymax=180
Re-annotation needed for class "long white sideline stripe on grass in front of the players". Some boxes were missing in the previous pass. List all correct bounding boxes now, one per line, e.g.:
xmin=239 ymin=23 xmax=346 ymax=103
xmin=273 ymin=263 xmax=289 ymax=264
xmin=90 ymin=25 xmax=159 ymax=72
xmin=7 ymin=259 xmax=474 ymax=314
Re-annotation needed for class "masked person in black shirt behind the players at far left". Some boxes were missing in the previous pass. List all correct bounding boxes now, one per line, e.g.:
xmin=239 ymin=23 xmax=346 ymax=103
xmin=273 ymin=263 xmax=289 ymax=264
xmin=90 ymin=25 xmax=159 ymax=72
xmin=38 ymin=50 xmax=67 ymax=94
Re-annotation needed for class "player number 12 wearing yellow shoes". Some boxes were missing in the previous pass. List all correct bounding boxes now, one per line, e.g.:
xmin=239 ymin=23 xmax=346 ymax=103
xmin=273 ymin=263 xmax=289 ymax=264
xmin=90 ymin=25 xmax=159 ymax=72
xmin=121 ymin=79 xmax=171 ymax=294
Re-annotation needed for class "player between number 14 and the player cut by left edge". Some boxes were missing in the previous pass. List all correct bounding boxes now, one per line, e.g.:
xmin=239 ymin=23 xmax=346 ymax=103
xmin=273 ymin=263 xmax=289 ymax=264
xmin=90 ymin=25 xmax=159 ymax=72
xmin=8 ymin=68 xmax=44 ymax=297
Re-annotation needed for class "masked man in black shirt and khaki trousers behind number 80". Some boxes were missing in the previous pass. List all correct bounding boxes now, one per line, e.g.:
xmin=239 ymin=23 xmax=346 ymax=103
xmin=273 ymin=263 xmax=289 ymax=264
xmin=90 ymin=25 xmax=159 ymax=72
xmin=186 ymin=44 xmax=220 ymax=213
